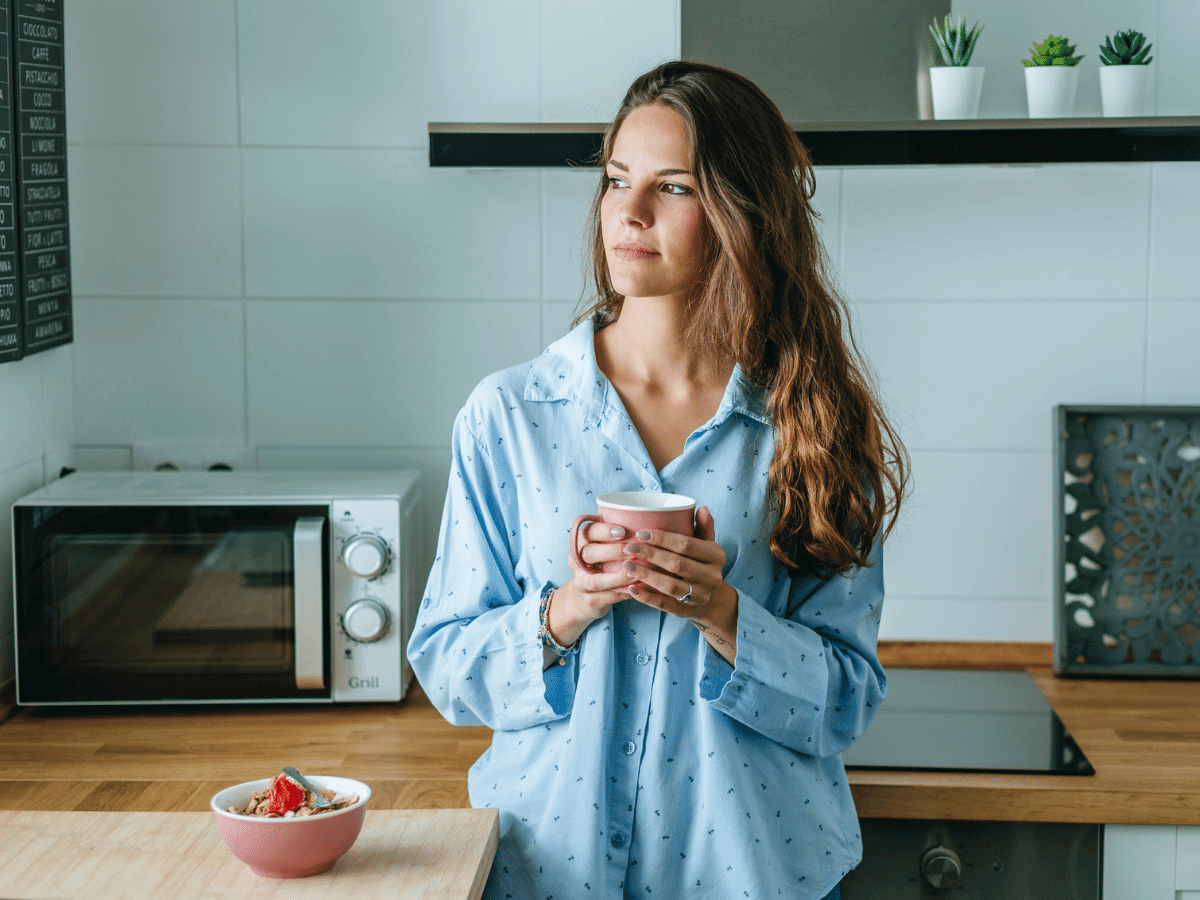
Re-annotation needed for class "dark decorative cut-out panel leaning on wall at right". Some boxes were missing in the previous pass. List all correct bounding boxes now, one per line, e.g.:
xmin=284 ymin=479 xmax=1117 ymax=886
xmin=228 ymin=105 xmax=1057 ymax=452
xmin=1055 ymin=406 xmax=1200 ymax=678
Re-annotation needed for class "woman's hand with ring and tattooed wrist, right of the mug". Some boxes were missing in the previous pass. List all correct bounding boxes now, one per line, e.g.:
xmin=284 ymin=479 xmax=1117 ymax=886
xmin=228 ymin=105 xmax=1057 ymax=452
xmin=606 ymin=506 xmax=738 ymax=665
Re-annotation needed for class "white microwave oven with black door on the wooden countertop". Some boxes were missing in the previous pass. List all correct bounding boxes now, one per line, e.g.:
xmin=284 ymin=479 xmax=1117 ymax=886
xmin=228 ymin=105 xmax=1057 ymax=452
xmin=12 ymin=472 xmax=424 ymax=706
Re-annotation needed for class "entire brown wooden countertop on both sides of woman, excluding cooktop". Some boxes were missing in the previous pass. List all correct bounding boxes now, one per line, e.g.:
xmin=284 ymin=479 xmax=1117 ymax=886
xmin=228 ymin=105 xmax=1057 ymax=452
xmin=0 ymin=644 xmax=1200 ymax=826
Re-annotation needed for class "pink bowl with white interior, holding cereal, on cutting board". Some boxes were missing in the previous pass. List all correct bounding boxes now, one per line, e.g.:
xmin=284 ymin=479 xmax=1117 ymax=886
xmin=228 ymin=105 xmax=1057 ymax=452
xmin=210 ymin=775 xmax=371 ymax=878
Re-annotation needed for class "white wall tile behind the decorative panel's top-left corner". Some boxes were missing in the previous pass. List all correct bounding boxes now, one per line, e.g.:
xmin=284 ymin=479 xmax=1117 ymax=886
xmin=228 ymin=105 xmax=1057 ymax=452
xmin=858 ymin=300 xmax=1146 ymax=450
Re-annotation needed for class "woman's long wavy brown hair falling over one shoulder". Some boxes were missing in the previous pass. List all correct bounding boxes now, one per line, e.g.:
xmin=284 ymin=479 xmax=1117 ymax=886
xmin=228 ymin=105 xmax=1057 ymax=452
xmin=576 ymin=61 xmax=910 ymax=574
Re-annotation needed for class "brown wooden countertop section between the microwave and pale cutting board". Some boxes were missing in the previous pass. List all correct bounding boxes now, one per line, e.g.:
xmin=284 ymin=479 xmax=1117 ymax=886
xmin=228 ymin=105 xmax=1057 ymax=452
xmin=0 ymin=686 xmax=491 ymax=812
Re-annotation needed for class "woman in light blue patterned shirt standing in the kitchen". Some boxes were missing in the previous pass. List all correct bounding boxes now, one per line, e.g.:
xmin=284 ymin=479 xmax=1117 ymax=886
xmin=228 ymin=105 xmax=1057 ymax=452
xmin=409 ymin=62 xmax=906 ymax=900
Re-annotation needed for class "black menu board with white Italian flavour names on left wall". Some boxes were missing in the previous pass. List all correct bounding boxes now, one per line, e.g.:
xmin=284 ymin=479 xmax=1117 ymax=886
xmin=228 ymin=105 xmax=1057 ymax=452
xmin=0 ymin=0 xmax=73 ymax=361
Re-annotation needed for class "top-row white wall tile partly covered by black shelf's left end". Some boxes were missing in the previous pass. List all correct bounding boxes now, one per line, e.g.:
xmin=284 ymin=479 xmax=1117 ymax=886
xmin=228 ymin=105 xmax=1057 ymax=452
xmin=238 ymin=0 xmax=541 ymax=149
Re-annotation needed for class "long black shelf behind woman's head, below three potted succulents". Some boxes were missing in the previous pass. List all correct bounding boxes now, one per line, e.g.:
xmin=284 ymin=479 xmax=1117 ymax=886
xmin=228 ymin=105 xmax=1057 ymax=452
xmin=428 ymin=116 xmax=1200 ymax=168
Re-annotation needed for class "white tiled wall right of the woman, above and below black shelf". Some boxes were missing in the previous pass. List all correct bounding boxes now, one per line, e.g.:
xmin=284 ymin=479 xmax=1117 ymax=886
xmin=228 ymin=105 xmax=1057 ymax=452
xmin=873 ymin=0 xmax=1200 ymax=641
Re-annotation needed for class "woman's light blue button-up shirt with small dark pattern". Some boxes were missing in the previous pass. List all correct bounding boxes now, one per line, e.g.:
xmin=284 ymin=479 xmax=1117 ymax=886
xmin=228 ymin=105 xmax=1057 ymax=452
xmin=408 ymin=322 xmax=886 ymax=900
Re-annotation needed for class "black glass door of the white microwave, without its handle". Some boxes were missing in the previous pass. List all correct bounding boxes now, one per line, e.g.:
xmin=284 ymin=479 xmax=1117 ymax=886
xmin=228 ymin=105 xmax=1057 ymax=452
xmin=17 ymin=506 xmax=330 ymax=702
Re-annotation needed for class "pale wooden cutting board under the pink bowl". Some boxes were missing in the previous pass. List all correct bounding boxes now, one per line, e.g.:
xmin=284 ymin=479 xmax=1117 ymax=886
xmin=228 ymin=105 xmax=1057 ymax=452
xmin=0 ymin=809 xmax=499 ymax=900
